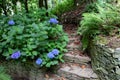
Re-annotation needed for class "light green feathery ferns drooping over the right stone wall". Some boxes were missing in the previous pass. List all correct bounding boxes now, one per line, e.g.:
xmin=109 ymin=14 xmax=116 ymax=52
xmin=78 ymin=4 xmax=120 ymax=50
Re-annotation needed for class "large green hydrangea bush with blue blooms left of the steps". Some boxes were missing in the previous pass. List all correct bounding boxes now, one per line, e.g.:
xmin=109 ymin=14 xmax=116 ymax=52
xmin=0 ymin=8 xmax=68 ymax=67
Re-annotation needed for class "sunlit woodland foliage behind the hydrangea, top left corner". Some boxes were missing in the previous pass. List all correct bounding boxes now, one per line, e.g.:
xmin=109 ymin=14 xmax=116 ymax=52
xmin=0 ymin=0 xmax=47 ymax=16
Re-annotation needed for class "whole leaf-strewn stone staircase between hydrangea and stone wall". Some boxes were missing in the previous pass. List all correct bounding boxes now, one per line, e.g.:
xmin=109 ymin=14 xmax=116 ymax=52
xmin=55 ymin=24 xmax=98 ymax=80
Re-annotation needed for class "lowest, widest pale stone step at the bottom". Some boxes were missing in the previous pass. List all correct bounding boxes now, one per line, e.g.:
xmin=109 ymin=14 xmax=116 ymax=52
xmin=58 ymin=65 xmax=99 ymax=80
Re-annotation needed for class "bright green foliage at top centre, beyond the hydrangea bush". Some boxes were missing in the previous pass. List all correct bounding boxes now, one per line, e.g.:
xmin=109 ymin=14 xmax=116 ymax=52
xmin=51 ymin=0 xmax=74 ymax=16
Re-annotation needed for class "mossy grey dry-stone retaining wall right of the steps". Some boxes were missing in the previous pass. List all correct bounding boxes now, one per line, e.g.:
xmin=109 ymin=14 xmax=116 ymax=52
xmin=90 ymin=44 xmax=120 ymax=80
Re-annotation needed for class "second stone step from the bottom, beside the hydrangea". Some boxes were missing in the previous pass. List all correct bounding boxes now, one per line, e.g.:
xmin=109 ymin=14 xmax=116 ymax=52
xmin=64 ymin=53 xmax=91 ymax=65
